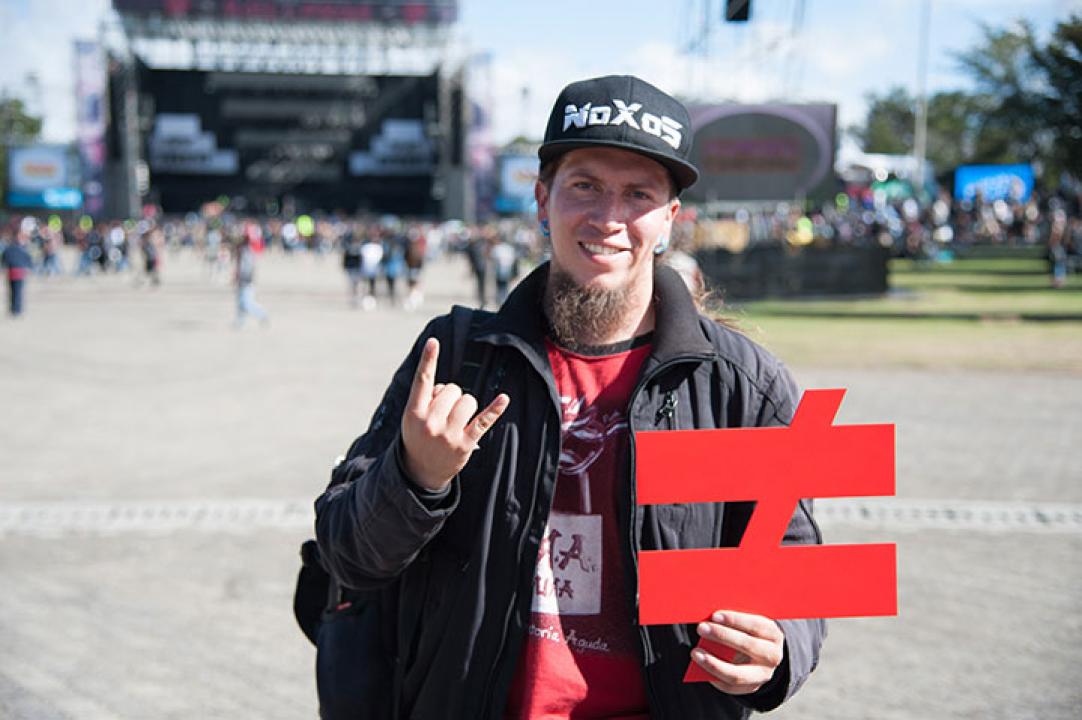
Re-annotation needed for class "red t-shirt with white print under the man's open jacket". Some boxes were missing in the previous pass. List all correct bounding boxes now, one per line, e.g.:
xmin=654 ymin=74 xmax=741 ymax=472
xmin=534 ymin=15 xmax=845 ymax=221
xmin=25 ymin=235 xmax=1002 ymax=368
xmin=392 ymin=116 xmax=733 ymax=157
xmin=504 ymin=341 xmax=650 ymax=720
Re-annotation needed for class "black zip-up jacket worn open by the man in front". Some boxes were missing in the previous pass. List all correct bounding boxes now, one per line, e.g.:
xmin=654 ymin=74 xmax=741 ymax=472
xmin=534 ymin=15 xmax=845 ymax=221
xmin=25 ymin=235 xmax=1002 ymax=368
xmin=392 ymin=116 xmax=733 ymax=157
xmin=316 ymin=260 xmax=826 ymax=720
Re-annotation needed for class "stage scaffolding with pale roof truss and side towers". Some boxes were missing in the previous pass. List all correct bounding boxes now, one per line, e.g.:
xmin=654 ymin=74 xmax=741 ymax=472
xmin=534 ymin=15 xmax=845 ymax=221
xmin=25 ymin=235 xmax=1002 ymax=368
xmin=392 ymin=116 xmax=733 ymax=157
xmin=101 ymin=0 xmax=473 ymax=219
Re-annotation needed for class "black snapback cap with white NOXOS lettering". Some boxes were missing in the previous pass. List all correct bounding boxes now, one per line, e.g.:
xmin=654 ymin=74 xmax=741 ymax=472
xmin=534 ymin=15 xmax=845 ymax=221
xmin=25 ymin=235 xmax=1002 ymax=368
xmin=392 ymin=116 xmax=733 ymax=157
xmin=538 ymin=75 xmax=699 ymax=191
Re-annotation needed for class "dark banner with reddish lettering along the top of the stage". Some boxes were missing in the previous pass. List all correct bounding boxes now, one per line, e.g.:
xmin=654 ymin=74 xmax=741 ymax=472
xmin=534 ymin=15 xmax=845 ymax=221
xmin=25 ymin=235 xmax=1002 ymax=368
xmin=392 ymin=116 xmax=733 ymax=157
xmin=113 ymin=0 xmax=459 ymax=24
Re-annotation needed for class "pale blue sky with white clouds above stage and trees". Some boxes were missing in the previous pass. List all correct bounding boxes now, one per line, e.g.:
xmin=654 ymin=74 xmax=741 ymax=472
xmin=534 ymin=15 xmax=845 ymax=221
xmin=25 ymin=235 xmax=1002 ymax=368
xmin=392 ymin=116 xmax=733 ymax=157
xmin=0 ymin=0 xmax=1082 ymax=154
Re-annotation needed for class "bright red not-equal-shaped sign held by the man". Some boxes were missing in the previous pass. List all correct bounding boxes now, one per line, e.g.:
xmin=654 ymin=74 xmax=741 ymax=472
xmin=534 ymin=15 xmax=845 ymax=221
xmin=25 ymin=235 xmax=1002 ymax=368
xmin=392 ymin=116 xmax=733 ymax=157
xmin=635 ymin=390 xmax=898 ymax=682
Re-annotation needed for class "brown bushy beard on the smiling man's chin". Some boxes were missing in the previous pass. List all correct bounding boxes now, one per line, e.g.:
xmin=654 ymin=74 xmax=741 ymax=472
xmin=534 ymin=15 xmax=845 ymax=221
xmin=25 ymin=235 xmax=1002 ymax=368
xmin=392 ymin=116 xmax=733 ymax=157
xmin=544 ymin=265 xmax=631 ymax=350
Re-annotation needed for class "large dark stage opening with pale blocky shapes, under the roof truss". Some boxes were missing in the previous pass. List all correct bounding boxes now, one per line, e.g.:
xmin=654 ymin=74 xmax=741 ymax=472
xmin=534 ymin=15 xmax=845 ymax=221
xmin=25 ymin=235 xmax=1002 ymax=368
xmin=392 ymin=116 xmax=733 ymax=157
xmin=140 ymin=68 xmax=440 ymax=215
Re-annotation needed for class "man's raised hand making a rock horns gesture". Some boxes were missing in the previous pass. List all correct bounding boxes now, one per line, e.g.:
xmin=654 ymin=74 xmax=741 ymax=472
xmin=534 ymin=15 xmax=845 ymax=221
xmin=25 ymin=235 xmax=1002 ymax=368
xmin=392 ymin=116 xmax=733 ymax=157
xmin=401 ymin=338 xmax=511 ymax=490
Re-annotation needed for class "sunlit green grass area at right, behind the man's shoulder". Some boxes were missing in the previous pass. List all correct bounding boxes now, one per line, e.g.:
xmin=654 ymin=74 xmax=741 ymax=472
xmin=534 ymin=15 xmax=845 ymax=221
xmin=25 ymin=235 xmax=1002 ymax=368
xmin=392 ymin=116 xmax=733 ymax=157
xmin=723 ymin=259 xmax=1082 ymax=374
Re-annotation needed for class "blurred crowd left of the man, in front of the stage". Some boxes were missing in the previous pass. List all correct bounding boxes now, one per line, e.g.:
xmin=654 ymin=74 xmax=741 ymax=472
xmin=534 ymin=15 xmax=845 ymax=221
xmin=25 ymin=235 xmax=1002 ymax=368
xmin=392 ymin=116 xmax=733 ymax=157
xmin=0 ymin=204 xmax=543 ymax=325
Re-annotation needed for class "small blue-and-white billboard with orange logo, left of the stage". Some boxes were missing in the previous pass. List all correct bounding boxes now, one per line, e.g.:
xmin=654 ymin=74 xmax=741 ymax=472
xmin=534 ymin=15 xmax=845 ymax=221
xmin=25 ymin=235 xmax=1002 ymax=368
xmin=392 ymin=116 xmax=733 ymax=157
xmin=8 ymin=145 xmax=82 ymax=210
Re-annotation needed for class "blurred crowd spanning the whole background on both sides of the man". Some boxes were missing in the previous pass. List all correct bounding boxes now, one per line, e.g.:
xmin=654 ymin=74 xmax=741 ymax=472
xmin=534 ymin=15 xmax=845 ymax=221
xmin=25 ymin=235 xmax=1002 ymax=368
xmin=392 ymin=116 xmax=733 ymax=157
xmin=0 ymin=176 xmax=1082 ymax=324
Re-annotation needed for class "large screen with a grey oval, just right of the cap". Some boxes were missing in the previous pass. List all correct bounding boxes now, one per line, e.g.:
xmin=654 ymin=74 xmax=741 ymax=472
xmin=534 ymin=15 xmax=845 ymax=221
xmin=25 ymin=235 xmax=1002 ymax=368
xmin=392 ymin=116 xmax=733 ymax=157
xmin=686 ymin=104 xmax=837 ymax=202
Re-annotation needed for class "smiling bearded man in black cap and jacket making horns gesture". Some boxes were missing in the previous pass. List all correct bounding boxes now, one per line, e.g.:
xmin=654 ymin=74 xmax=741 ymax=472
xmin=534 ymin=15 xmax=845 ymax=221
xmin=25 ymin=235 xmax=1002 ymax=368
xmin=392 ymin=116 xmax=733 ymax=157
xmin=316 ymin=77 xmax=824 ymax=719
